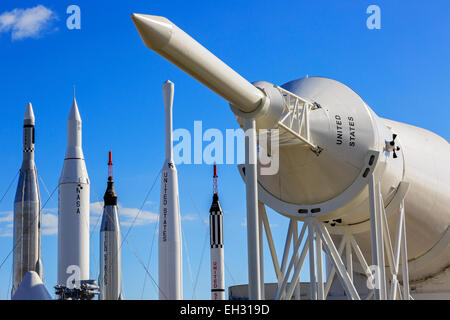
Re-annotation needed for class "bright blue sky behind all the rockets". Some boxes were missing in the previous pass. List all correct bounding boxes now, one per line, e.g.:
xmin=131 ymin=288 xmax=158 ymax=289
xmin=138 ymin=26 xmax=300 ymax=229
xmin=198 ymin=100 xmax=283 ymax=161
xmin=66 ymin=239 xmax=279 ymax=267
xmin=0 ymin=0 xmax=450 ymax=299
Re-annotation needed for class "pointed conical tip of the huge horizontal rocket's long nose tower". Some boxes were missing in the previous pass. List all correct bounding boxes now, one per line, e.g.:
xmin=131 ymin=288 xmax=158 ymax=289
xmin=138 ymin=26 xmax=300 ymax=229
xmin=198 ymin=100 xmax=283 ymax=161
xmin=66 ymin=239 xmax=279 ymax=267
xmin=131 ymin=13 xmax=173 ymax=50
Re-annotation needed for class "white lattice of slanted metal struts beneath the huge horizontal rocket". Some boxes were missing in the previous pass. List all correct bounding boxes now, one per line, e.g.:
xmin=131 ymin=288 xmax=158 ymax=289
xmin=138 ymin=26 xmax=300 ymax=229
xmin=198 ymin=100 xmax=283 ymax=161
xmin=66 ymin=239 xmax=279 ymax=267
xmin=258 ymin=176 xmax=410 ymax=300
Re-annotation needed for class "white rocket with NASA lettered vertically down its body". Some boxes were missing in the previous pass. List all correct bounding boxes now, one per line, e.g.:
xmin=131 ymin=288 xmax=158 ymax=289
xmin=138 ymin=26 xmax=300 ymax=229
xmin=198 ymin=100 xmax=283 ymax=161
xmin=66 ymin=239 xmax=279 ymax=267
xmin=58 ymin=97 xmax=90 ymax=289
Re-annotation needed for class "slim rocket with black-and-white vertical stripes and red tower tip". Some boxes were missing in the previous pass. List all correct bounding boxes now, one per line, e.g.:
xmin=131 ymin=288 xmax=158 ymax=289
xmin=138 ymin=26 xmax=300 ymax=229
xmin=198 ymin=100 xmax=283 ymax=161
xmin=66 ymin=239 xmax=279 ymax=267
xmin=209 ymin=165 xmax=225 ymax=300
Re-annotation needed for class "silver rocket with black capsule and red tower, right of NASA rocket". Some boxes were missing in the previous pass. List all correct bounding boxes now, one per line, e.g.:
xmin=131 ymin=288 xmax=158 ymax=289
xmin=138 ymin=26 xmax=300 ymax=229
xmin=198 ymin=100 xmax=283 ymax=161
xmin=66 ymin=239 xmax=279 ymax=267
xmin=99 ymin=151 xmax=122 ymax=300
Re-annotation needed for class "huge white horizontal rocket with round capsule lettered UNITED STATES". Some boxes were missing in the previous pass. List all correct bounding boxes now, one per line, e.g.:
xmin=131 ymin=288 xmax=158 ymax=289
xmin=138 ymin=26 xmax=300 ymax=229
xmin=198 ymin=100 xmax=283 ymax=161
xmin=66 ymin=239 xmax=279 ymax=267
xmin=132 ymin=14 xmax=450 ymax=298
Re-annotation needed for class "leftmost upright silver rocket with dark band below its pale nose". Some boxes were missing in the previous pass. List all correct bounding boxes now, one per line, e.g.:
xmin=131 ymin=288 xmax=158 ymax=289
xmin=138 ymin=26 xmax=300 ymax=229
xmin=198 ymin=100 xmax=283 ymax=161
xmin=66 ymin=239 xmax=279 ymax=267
xmin=11 ymin=103 xmax=43 ymax=295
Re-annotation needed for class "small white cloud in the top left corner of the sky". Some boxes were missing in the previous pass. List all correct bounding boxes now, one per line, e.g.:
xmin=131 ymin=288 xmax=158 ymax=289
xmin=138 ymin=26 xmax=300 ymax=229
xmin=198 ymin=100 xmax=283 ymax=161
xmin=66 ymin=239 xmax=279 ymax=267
xmin=0 ymin=5 xmax=56 ymax=40
